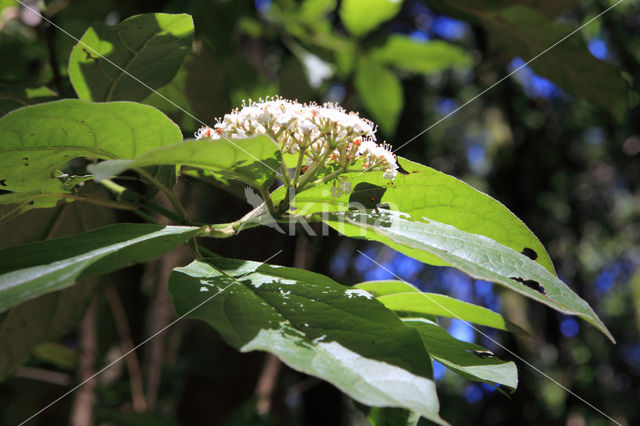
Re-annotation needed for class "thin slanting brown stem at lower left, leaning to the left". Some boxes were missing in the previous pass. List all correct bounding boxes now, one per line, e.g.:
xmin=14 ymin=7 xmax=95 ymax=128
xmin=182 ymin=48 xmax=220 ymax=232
xmin=102 ymin=284 xmax=147 ymax=413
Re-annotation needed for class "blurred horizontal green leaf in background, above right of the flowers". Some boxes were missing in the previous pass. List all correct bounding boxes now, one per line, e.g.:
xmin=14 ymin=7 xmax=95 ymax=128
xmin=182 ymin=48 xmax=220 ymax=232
xmin=370 ymin=34 xmax=472 ymax=73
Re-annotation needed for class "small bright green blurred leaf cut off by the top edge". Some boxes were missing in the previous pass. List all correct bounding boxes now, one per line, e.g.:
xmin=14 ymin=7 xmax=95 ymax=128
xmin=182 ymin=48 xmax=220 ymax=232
xmin=340 ymin=0 xmax=402 ymax=37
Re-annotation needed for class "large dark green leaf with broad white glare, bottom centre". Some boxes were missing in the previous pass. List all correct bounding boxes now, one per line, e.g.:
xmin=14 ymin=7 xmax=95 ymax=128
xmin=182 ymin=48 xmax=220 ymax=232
xmin=169 ymin=258 xmax=446 ymax=424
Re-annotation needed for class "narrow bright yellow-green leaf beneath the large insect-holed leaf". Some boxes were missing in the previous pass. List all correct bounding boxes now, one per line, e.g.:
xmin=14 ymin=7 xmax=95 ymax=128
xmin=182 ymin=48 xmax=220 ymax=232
xmin=354 ymin=281 xmax=525 ymax=333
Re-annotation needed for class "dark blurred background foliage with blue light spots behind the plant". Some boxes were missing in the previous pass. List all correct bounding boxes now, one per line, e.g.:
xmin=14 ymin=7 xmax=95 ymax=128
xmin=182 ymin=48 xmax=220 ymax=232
xmin=0 ymin=0 xmax=640 ymax=426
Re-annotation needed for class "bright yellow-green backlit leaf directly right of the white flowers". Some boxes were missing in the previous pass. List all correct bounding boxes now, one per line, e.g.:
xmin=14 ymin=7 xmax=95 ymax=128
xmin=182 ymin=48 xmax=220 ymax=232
xmin=274 ymin=157 xmax=555 ymax=273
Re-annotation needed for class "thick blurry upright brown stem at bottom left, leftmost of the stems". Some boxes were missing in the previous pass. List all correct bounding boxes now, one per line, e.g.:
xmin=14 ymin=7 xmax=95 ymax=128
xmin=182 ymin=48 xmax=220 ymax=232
xmin=69 ymin=296 xmax=98 ymax=426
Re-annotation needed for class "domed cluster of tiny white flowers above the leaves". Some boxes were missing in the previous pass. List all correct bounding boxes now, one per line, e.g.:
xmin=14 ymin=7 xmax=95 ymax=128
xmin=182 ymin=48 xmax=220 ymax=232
xmin=195 ymin=98 xmax=398 ymax=180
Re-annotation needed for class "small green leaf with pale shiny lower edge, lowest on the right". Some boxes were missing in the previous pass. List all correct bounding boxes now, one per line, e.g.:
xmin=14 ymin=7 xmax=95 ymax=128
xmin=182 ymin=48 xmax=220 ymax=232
xmin=403 ymin=318 xmax=518 ymax=390
